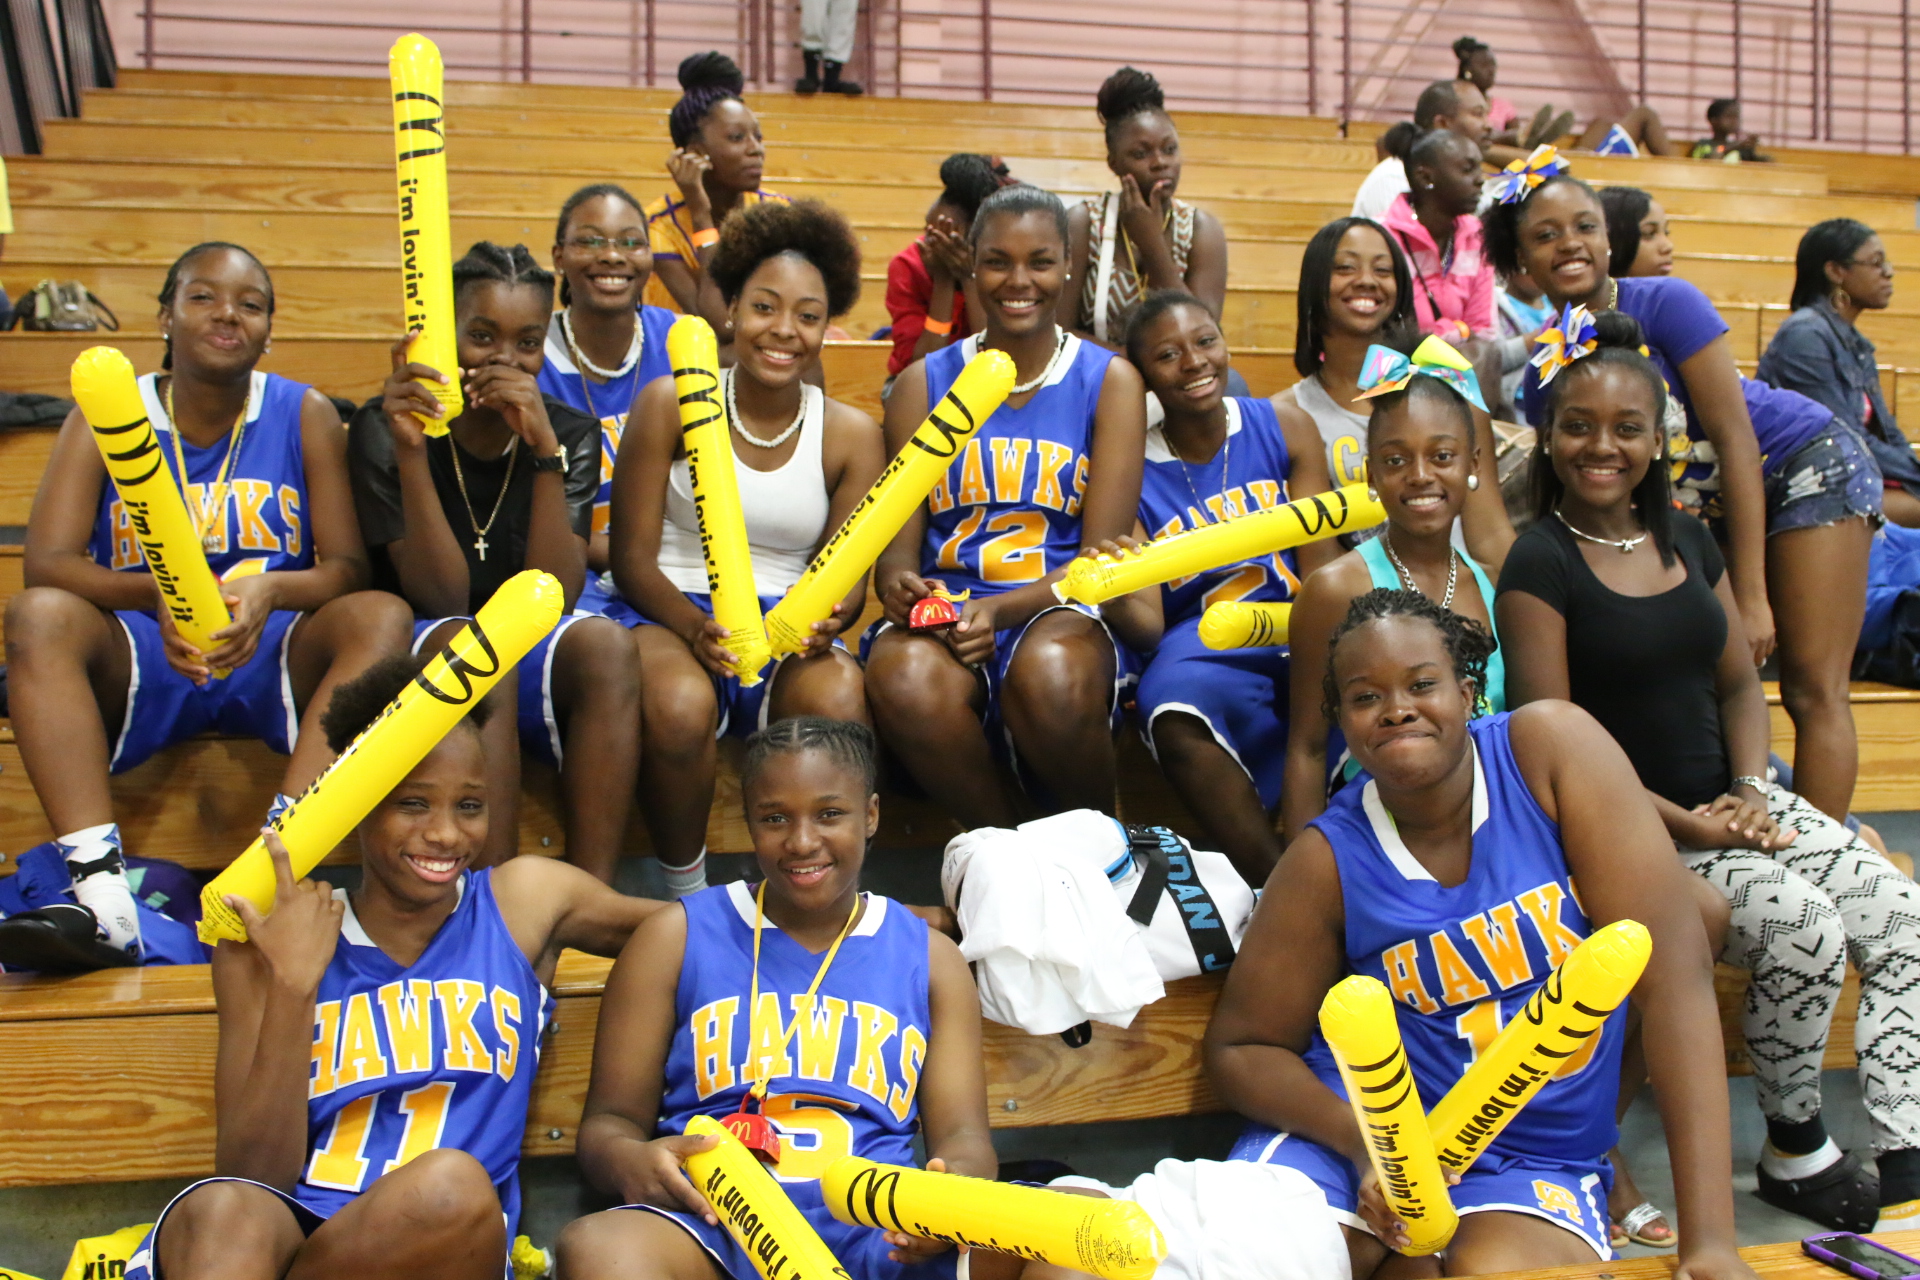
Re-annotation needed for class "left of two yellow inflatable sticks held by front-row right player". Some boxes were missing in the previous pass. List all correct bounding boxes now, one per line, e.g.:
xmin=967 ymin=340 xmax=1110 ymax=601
xmin=1321 ymin=973 xmax=1459 ymax=1257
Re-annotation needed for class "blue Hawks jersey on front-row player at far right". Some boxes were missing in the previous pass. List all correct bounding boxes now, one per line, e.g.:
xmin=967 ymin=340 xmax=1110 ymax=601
xmin=1306 ymin=714 xmax=1626 ymax=1161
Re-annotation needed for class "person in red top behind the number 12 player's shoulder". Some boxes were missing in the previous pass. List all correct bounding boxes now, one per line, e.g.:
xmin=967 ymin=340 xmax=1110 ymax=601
xmin=887 ymin=152 xmax=1000 ymax=388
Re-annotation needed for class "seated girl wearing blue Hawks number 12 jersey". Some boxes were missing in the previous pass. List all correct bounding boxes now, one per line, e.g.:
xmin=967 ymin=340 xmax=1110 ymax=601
xmin=866 ymin=186 xmax=1146 ymax=827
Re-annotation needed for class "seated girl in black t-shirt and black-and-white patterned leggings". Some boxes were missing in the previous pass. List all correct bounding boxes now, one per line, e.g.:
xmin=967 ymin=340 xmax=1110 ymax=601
xmin=1498 ymin=312 xmax=1920 ymax=1236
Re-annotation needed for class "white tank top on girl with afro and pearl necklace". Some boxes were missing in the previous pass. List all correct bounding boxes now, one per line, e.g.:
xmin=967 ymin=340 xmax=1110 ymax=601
xmin=660 ymin=384 xmax=829 ymax=595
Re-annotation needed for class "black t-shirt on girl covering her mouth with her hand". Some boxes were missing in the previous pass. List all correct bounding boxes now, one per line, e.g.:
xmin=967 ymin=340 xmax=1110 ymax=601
xmin=348 ymin=395 xmax=601 ymax=612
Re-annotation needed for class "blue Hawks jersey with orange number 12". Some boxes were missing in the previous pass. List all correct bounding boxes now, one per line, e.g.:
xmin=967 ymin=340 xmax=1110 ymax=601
xmin=920 ymin=334 xmax=1116 ymax=595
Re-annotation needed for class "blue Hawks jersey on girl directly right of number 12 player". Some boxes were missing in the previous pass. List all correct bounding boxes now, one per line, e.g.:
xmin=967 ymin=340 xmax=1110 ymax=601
xmin=1140 ymin=397 xmax=1300 ymax=626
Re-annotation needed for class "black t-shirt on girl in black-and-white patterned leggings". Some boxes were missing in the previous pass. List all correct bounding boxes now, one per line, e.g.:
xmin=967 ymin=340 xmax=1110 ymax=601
xmin=1500 ymin=512 xmax=1732 ymax=808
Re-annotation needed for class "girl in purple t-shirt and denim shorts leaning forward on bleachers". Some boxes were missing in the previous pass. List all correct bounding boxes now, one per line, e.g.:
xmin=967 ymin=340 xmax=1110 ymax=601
xmin=1484 ymin=163 xmax=1880 ymax=819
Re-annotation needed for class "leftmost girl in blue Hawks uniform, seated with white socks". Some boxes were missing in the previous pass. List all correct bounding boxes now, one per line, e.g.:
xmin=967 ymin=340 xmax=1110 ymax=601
xmin=6 ymin=244 xmax=407 ymax=967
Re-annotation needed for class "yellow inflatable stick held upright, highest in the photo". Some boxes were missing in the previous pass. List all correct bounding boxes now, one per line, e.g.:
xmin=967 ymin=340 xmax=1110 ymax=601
xmin=386 ymin=35 xmax=463 ymax=436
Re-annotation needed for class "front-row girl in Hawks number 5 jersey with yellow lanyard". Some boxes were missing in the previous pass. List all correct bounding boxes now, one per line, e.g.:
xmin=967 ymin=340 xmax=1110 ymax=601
xmin=557 ymin=716 xmax=1012 ymax=1280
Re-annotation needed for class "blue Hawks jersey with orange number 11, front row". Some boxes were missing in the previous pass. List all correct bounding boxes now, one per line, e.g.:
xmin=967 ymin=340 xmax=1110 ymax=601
xmin=294 ymin=871 xmax=553 ymax=1240
